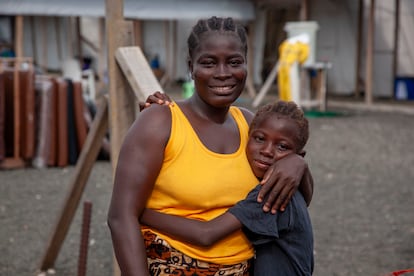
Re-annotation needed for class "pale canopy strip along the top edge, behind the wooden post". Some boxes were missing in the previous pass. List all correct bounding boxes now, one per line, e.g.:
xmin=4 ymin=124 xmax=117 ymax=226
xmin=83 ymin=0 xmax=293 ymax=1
xmin=0 ymin=0 xmax=255 ymax=20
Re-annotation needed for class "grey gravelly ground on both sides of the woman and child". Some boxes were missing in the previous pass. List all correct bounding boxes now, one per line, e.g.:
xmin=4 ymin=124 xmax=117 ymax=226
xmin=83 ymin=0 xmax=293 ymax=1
xmin=0 ymin=93 xmax=414 ymax=276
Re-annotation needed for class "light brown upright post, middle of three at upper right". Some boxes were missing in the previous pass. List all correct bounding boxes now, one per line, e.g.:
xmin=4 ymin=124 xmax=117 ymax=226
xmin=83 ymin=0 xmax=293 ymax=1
xmin=365 ymin=0 xmax=375 ymax=105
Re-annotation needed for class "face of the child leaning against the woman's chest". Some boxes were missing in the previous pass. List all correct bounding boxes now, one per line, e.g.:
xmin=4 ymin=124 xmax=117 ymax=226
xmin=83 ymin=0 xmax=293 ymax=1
xmin=246 ymin=114 xmax=299 ymax=178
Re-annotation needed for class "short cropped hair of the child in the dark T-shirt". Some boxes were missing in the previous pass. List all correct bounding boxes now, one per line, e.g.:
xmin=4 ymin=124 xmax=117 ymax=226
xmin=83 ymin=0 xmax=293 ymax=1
xmin=249 ymin=101 xmax=309 ymax=150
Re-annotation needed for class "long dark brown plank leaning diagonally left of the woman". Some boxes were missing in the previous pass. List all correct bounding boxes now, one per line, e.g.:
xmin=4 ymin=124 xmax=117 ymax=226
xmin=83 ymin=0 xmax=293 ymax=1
xmin=40 ymin=98 xmax=108 ymax=271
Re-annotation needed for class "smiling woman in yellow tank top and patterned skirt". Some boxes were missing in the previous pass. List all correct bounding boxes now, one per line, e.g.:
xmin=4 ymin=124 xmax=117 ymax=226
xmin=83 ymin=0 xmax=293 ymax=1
xmin=108 ymin=17 xmax=312 ymax=276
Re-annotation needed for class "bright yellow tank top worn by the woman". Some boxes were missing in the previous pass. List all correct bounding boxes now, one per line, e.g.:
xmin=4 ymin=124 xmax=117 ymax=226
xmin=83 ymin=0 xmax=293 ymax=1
xmin=143 ymin=104 xmax=258 ymax=264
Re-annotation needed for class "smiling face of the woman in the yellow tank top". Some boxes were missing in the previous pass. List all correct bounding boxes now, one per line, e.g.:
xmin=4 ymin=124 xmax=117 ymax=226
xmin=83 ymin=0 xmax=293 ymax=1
xmin=189 ymin=32 xmax=247 ymax=107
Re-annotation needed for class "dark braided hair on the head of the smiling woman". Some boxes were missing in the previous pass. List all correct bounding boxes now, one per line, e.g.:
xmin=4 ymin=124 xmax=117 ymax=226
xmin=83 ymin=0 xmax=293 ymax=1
xmin=187 ymin=16 xmax=247 ymax=58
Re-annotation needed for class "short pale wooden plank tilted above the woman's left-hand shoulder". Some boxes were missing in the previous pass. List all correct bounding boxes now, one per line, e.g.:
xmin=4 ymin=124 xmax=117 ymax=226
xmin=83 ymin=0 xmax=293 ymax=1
xmin=115 ymin=46 xmax=163 ymax=101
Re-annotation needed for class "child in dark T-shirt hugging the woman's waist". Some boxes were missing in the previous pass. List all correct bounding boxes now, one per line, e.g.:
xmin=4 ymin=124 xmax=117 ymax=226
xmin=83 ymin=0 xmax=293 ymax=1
xmin=141 ymin=101 xmax=313 ymax=276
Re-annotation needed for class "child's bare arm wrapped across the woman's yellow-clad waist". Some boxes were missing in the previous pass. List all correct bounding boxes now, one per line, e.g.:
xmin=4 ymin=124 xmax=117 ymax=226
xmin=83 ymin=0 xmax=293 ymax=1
xmin=140 ymin=209 xmax=242 ymax=246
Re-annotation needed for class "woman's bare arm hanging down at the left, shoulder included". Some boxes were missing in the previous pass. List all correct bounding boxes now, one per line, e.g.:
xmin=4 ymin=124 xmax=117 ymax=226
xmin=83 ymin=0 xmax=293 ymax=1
xmin=108 ymin=106 xmax=171 ymax=276
